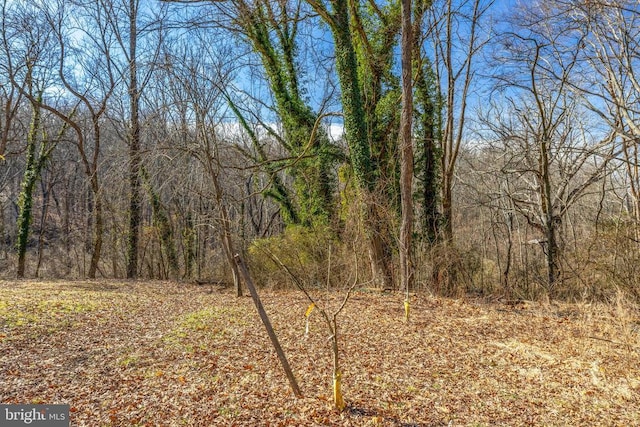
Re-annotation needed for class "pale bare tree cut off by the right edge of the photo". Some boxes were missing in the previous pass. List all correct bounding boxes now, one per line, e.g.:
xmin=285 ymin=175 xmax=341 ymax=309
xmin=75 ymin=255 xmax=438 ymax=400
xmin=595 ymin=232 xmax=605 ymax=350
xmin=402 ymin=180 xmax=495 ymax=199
xmin=548 ymin=0 xmax=640 ymax=232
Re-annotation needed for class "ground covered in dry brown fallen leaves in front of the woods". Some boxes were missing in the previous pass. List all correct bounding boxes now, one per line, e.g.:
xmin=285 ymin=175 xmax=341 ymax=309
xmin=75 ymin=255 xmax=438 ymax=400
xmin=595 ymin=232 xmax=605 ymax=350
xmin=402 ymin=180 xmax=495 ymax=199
xmin=0 ymin=281 xmax=640 ymax=427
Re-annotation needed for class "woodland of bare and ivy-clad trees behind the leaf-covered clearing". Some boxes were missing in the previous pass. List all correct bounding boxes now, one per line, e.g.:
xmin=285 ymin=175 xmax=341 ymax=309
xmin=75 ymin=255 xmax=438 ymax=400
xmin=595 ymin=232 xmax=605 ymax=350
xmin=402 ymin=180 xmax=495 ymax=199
xmin=0 ymin=0 xmax=640 ymax=298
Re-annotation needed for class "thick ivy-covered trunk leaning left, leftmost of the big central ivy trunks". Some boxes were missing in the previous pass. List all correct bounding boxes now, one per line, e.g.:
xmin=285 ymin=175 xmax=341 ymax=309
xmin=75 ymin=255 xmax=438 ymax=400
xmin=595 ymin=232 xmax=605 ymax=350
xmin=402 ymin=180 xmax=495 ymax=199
xmin=234 ymin=0 xmax=335 ymax=226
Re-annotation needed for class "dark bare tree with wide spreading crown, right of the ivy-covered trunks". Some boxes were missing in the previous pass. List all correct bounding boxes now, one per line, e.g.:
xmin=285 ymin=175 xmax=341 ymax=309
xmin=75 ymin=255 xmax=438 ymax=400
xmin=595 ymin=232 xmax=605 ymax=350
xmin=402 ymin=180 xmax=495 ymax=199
xmin=484 ymin=9 xmax=615 ymax=293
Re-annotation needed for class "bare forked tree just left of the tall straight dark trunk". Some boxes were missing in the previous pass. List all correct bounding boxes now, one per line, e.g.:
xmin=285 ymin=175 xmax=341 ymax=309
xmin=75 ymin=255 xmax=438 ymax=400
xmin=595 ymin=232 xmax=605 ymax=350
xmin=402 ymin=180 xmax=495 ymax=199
xmin=42 ymin=1 xmax=117 ymax=278
